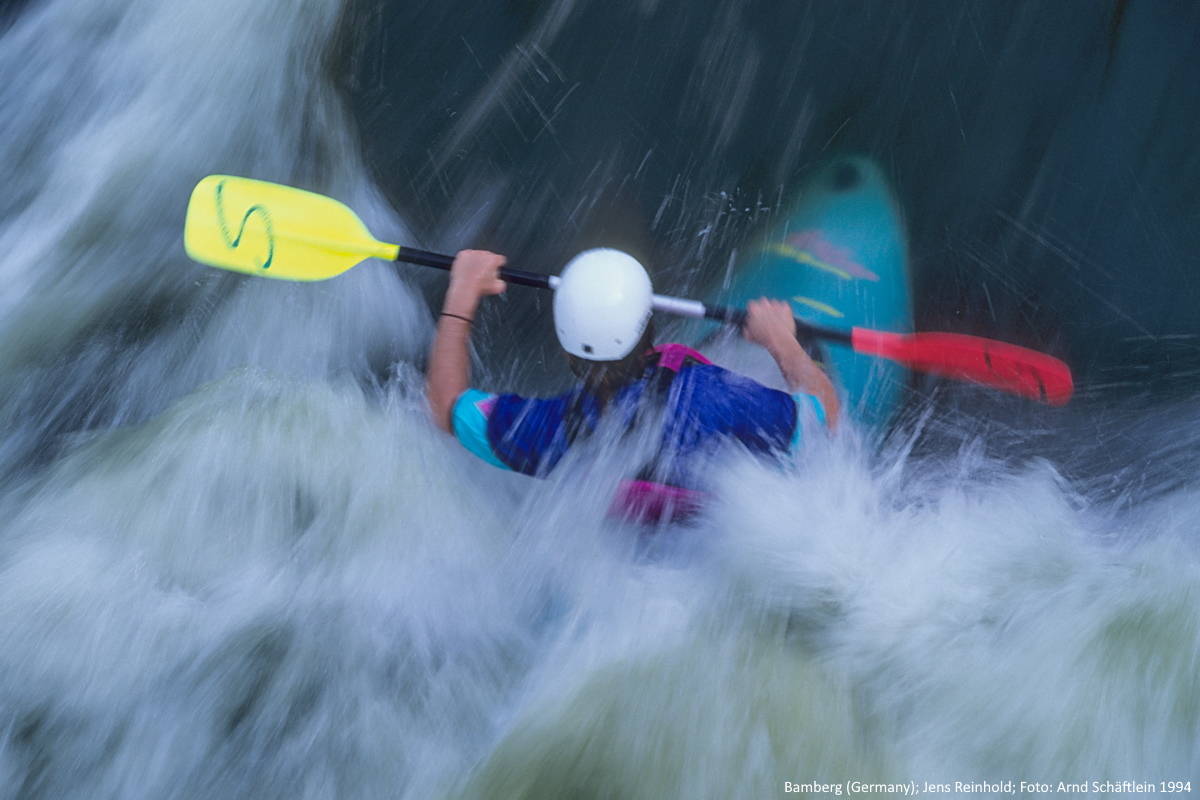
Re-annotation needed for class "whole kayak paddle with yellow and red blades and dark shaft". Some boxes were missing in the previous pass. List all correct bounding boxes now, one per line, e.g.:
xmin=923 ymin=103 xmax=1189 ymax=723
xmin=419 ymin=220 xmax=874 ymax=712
xmin=184 ymin=175 xmax=1074 ymax=405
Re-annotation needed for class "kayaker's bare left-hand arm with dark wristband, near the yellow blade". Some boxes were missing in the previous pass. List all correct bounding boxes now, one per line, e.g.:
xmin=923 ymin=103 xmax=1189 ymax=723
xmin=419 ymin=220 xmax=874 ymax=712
xmin=425 ymin=249 xmax=506 ymax=433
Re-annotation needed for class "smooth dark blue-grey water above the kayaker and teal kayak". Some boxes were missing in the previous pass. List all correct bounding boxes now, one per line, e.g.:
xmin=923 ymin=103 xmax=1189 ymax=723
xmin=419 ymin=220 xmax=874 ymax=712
xmin=341 ymin=0 xmax=1200 ymax=396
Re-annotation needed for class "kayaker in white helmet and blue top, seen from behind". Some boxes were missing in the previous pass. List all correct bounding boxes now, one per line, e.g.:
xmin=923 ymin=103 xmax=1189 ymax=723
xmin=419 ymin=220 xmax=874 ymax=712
xmin=426 ymin=249 xmax=839 ymax=519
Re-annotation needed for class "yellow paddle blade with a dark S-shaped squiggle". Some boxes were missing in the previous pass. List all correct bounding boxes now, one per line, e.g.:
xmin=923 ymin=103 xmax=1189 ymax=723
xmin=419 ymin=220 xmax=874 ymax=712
xmin=184 ymin=175 xmax=400 ymax=281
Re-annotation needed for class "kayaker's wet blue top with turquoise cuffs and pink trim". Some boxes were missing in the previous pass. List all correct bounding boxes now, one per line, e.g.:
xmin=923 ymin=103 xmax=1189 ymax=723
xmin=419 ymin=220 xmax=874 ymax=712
xmin=454 ymin=344 xmax=826 ymax=521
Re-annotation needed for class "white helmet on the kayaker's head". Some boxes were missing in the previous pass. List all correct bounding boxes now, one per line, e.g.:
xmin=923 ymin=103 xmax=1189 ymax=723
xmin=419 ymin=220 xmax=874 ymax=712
xmin=554 ymin=247 xmax=654 ymax=361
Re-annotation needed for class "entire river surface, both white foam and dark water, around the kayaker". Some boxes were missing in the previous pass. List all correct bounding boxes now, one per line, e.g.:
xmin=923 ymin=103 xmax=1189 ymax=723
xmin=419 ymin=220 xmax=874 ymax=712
xmin=0 ymin=0 xmax=1200 ymax=800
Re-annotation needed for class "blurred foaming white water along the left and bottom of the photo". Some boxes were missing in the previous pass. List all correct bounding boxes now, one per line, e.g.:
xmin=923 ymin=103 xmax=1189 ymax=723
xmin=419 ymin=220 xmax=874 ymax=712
xmin=0 ymin=0 xmax=1200 ymax=800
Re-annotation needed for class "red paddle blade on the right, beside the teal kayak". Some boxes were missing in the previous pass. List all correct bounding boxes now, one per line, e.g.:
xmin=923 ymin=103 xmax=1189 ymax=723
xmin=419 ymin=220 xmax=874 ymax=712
xmin=852 ymin=327 xmax=1075 ymax=405
